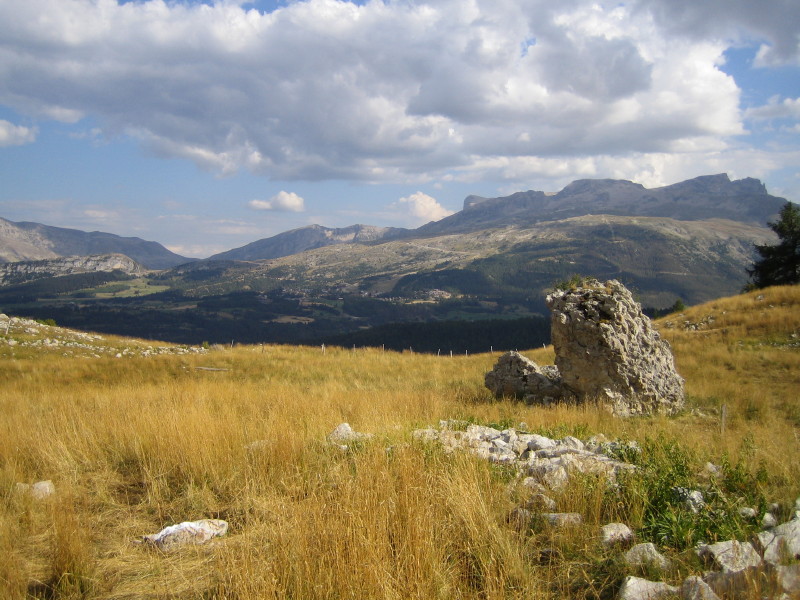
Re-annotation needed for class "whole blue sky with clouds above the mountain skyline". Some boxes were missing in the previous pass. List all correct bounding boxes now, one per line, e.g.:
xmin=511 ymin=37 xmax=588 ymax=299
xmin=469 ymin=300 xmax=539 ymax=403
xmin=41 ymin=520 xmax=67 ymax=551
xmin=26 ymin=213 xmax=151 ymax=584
xmin=0 ymin=0 xmax=800 ymax=257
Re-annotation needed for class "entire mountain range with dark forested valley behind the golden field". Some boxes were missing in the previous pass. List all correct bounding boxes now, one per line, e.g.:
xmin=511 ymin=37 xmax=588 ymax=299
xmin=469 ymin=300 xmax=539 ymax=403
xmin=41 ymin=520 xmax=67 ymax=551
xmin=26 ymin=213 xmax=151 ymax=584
xmin=0 ymin=174 xmax=786 ymax=347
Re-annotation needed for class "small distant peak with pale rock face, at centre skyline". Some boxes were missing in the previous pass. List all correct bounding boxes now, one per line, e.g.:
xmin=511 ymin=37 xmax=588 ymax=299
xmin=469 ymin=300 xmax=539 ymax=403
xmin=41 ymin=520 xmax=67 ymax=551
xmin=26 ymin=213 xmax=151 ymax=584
xmin=209 ymin=225 xmax=405 ymax=260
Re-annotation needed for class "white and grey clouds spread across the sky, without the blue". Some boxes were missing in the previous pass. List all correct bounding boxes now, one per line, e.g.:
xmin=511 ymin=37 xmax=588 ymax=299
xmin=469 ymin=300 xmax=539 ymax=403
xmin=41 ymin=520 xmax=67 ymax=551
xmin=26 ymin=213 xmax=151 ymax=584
xmin=0 ymin=0 xmax=800 ymax=191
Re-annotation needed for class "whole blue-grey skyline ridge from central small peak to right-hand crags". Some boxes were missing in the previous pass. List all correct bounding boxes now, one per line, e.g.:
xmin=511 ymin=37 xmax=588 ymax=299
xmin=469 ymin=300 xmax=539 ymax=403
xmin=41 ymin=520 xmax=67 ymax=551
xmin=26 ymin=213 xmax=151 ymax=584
xmin=208 ymin=173 xmax=786 ymax=260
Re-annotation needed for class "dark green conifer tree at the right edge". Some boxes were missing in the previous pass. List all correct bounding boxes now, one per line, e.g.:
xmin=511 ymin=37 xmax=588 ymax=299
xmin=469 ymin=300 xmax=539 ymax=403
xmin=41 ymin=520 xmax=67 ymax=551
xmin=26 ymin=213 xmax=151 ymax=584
xmin=747 ymin=202 xmax=800 ymax=288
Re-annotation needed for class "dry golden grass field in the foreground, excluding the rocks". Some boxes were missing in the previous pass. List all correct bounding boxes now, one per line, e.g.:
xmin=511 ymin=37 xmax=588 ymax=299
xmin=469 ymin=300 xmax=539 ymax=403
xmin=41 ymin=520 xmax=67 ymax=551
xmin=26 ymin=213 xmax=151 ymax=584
xmin=0 ymin=286 xmax=800 ymax=600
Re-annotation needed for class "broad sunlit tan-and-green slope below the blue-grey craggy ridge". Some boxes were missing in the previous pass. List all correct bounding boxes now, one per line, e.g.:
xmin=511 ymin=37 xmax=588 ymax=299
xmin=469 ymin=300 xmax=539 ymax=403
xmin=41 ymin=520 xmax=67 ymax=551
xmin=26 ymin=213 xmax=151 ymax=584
xmin=156 ymin=215 xmax=774 ymax=307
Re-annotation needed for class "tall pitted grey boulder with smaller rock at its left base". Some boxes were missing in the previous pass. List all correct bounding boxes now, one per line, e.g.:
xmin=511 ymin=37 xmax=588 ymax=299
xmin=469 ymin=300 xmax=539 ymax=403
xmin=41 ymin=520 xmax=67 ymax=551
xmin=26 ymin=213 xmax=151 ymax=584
xmin=485 ymin=280 xmax=684 ymax=416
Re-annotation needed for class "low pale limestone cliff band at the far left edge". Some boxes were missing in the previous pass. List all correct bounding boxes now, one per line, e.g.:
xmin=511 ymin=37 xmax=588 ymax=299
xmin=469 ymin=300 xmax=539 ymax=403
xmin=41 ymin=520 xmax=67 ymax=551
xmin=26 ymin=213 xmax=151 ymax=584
xmin=0 ymin=254 xmax=145 ymax=285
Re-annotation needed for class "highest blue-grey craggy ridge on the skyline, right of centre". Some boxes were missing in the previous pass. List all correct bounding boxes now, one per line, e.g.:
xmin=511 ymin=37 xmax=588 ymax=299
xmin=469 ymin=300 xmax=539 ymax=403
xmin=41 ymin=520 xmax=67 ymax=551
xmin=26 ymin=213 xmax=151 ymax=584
xmin=414 ymin=174 xmax=786 ymax=236
